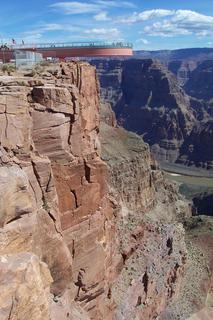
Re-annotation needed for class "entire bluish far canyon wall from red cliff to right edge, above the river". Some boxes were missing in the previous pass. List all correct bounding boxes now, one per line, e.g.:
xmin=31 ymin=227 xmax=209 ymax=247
xmin=92 ymin=49 xmax=213 ymax=170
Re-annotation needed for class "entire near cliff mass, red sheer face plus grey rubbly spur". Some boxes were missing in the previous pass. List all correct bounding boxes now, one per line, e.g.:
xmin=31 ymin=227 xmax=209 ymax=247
xmin=0 ymin=62 xmax=189 ymax=320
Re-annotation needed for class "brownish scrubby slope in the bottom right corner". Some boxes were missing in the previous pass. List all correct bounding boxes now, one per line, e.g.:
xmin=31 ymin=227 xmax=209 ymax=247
xmin=159 ymin=216 xmax=213 ymax=320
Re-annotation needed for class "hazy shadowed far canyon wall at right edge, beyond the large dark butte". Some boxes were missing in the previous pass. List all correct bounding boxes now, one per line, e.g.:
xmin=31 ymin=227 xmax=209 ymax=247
xmin=176 ymin=60 xmax=213 ymax=170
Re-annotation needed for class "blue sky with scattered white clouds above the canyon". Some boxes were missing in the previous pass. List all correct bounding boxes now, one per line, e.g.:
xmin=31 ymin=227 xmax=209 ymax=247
xmin=0 ymin=0 xmax=213 ymax=50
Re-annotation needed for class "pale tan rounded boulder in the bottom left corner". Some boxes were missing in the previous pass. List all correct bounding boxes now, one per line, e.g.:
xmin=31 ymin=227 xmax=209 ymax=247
xmin=0 ymin=253 xmax=52 ymax=320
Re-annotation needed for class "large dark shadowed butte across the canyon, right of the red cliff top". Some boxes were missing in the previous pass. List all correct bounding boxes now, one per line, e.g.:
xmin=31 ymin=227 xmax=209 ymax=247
xmin=93 ymin=59 xmax=195 ymax=162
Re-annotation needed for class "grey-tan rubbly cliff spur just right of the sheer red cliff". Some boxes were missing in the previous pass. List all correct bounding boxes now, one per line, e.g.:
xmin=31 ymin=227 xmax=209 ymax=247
xmin=101 ymin=105 xmax=190 ymax=320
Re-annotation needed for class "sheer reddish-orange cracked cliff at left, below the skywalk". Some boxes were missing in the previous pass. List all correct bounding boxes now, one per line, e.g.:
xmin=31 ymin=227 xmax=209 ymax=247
xmin=0 ymin=63 xmax=113 ymax=320
